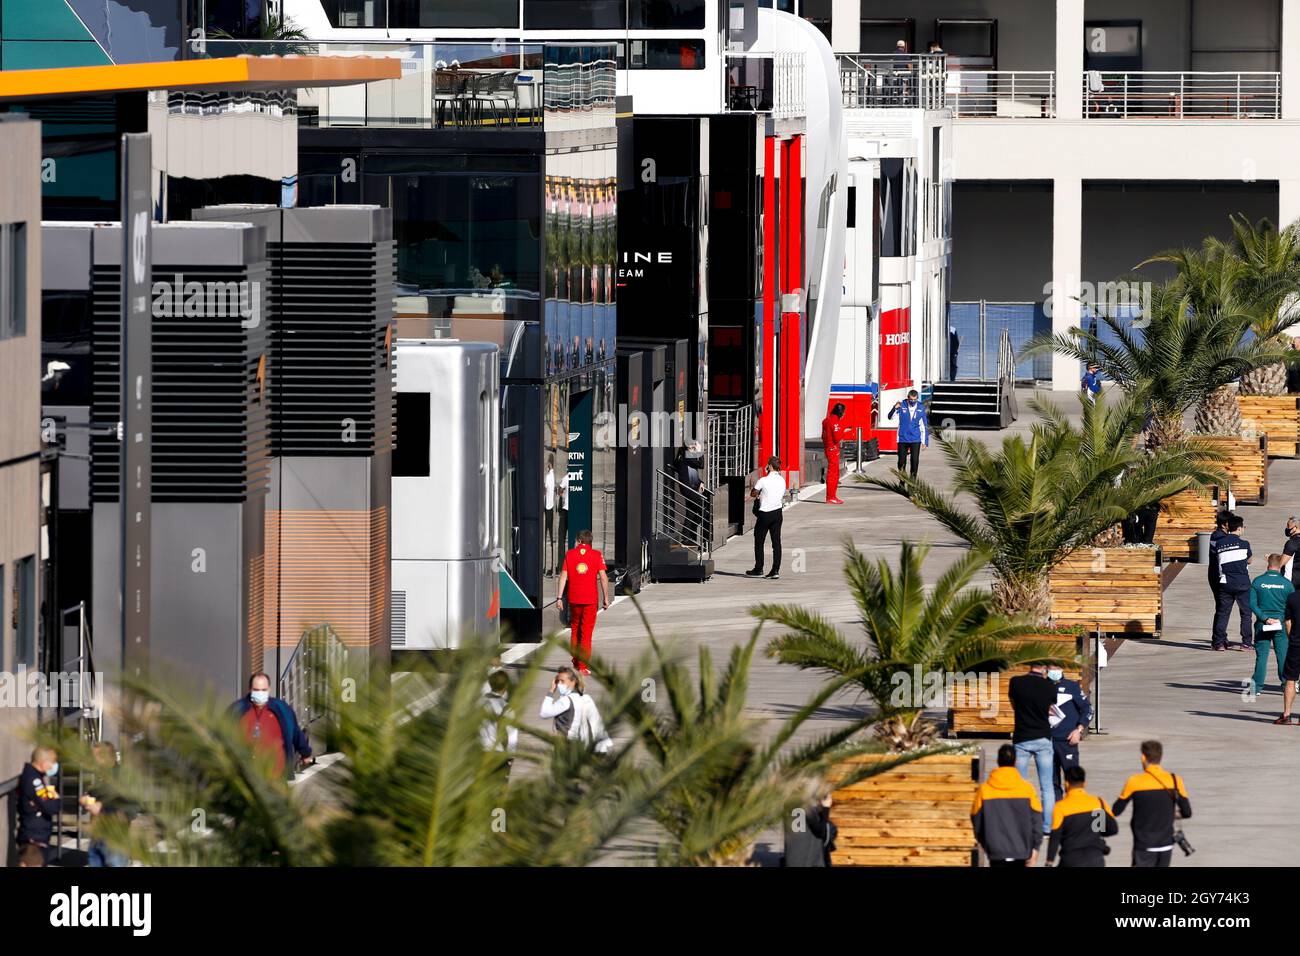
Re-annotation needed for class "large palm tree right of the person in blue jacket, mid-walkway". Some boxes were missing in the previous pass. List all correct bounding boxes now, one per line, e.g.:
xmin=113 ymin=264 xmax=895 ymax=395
xmin=862 ymin=395 xmax=1222 ymax=626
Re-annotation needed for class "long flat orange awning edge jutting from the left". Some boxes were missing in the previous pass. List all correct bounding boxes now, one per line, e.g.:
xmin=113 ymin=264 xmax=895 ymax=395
xmin=0 ymin=56 xmax=402 ymax=101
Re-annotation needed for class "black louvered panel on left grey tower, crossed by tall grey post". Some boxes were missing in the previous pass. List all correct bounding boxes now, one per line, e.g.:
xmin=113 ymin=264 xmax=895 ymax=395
xmin=92 ymin=261 xmax=273 ymax=502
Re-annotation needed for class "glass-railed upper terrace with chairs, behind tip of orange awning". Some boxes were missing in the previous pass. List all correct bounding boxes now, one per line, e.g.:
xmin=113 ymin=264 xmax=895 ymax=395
xmin=196 ymin=40 xmax=616 ymax=130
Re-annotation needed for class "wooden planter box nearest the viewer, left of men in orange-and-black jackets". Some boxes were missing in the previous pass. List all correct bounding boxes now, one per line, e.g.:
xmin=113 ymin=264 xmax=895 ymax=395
xmin=831 ymin=753 xmax=983 ymax=866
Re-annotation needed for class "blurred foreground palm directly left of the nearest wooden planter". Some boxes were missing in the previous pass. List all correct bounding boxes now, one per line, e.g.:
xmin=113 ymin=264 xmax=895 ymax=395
xmin=593 ymin=613 xmax=931 ymax=866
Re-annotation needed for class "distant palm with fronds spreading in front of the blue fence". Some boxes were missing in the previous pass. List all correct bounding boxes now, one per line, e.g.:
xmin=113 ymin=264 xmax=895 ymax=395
xmin=1023 ymin=280 xmax=1284 ymax=447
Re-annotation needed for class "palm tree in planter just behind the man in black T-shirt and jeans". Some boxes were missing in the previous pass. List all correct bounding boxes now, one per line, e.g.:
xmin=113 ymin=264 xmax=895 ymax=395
xmin=750 ymin=541 xmax=1060 ymax=750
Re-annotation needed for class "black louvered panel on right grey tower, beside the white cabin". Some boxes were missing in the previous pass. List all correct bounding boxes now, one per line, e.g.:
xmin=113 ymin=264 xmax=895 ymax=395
xmin=269 ymin=241 xmax=394 ymax=457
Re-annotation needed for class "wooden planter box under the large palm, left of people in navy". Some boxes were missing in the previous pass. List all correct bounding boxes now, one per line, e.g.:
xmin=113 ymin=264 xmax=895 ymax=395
xmin=1050 ymin=546 xmax=1165 ymax=637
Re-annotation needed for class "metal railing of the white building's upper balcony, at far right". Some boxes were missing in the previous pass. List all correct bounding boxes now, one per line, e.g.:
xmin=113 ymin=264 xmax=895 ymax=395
xmin=1083 ymin=70 xmax=1282 ymax=120
